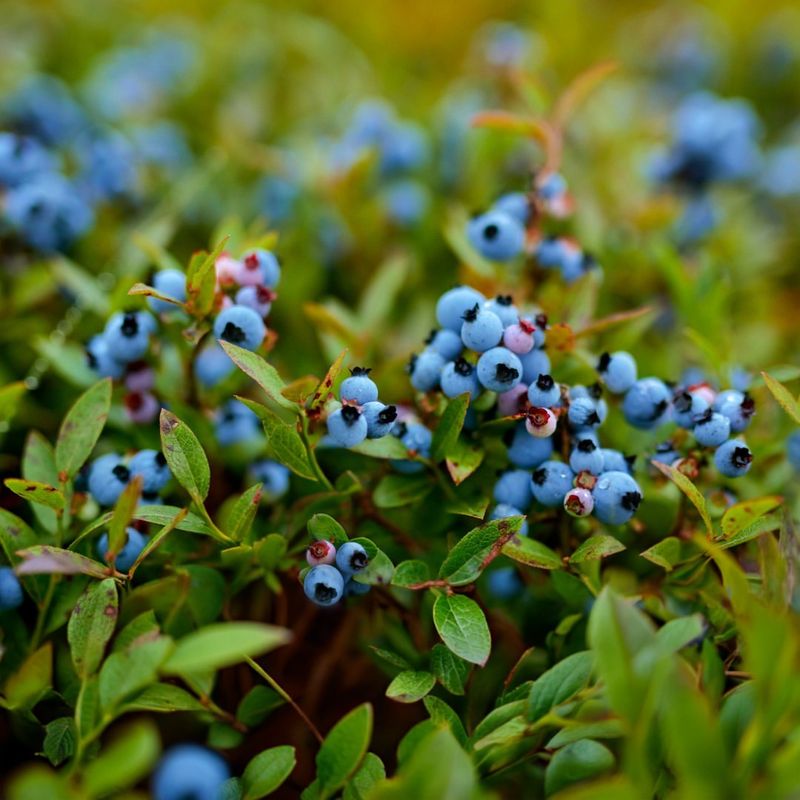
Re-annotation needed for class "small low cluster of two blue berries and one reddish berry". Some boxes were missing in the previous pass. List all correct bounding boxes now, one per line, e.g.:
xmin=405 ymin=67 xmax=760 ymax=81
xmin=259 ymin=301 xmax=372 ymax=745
xmin=303 ymin=539 xmax=370 ymax=606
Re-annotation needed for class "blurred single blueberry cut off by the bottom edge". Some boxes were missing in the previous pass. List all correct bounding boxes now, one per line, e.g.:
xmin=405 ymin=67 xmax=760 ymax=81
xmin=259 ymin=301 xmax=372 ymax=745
xmin=153 ymin=744 xmax=230 ymax=800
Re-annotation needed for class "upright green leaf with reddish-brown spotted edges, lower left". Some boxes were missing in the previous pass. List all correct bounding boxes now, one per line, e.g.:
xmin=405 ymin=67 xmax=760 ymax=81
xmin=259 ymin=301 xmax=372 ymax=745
xmin=67 ymin=578 xmax=119 ymax=678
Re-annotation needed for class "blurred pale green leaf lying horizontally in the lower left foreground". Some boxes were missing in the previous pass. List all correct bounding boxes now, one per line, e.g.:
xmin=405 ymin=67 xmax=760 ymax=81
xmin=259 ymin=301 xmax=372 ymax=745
xmin=162 ymin=622 xmax=291 ymax=675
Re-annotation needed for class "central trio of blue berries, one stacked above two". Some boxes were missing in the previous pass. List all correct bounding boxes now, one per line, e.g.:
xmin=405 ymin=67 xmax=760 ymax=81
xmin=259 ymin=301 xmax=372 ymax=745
xmin=328 ymin=367 xmax=397 ymax=447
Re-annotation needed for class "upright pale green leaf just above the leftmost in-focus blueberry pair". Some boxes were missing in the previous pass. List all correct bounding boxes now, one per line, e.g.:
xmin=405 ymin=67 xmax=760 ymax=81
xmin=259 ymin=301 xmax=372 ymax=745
xmin=55 ymin=378 xmax=111 ymax=478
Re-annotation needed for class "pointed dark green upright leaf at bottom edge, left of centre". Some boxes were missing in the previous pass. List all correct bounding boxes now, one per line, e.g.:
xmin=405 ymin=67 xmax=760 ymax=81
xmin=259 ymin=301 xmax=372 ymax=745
xmin=317 ymin=703 xmax=372 ymax=798
